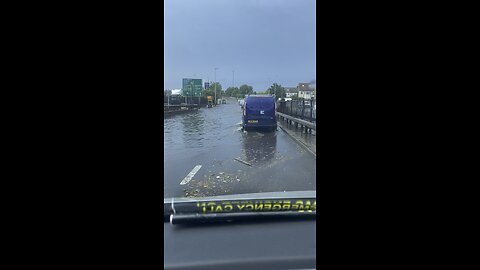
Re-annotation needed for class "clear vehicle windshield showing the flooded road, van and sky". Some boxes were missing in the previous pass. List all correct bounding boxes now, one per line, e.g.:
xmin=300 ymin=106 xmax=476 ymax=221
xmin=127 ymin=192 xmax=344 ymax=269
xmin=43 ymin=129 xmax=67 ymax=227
xmin=163 ymin=0 xmax=317 ymax=200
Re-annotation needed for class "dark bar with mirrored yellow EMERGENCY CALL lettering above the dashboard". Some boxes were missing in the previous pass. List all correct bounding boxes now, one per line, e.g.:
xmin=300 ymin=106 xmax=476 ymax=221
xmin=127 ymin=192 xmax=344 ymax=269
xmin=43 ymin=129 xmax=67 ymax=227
xmin=164 ymin=191 xmax=316 ymax=224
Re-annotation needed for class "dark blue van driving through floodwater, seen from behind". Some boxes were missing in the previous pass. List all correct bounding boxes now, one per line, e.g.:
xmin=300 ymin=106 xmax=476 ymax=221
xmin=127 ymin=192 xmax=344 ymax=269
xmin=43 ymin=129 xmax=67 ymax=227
xmin=242 ymin=95 xmax=277 ymax=130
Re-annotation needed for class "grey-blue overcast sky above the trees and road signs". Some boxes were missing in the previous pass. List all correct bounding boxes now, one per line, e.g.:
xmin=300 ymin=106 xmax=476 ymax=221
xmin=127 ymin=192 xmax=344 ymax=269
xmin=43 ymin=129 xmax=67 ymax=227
xmin=163 ymin=0 xmax=316 ymax=91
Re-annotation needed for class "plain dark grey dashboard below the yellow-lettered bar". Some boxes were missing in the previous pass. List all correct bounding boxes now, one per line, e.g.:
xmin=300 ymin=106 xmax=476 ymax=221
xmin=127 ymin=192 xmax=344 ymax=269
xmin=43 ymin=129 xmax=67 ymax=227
xmin=163 ymin=220 xmax=316 ymax=270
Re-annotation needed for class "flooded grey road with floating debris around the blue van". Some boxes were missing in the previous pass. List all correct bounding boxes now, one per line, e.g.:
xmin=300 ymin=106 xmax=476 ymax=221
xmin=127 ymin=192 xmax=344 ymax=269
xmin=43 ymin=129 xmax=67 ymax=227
xmin=164 ymin=99 xmax=316 ymax=198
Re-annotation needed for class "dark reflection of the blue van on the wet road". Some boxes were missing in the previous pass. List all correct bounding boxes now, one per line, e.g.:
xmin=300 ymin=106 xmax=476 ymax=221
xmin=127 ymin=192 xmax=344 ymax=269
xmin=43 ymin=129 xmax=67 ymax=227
xmin=242 ymin=131 xmax=277 ymax=165
